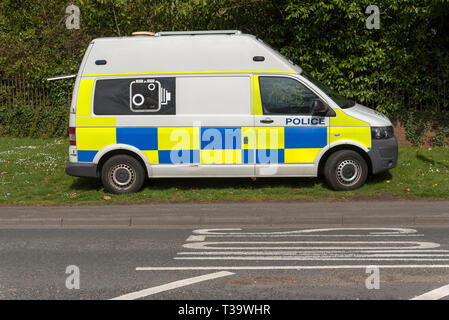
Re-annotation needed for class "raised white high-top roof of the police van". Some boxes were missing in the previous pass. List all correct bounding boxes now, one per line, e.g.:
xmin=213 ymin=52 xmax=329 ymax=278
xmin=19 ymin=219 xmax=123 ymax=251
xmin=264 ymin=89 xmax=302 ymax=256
xmin=82 ymin=30 xmax=301 ymax=76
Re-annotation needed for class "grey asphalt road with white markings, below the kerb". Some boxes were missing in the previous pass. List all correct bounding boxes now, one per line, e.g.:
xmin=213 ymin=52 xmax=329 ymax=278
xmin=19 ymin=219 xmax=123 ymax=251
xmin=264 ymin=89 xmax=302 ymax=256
xmin=0 ymin=225 xmax=449 ymax=300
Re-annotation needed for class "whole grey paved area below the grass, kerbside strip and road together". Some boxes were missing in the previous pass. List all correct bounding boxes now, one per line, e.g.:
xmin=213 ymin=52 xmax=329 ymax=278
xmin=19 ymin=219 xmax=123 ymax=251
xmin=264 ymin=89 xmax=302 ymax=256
xmin=0 ymin=201 xmax=449 ymax=300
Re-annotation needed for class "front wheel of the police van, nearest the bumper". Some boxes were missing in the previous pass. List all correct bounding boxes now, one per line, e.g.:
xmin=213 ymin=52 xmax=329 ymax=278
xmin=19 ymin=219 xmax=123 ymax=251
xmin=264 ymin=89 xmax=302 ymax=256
xmin=324 ymin=150 xmax=368 ymax=190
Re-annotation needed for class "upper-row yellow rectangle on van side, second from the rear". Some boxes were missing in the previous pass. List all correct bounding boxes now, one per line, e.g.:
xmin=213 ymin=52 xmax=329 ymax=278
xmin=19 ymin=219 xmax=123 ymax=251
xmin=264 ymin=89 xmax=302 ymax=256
xmin=157 ymin=127 xmax=200 ymax=150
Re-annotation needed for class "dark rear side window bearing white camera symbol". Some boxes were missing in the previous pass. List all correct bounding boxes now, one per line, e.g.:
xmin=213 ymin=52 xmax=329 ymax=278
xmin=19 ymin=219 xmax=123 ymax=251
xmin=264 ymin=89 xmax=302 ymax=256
xmin=94 ymin=78 xmax=176 ymax=115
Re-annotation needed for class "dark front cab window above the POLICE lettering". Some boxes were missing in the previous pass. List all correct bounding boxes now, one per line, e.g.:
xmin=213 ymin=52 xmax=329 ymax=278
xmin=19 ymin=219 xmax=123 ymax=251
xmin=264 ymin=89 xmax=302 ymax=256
xmin=259 ymin=77 xmax=319 ymax=116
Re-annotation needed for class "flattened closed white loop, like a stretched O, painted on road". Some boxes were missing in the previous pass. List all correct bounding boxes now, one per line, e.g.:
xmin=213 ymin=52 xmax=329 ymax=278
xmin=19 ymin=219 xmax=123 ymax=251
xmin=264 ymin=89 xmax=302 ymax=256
xmin=183 ymin=241 xmax=440 ymax=250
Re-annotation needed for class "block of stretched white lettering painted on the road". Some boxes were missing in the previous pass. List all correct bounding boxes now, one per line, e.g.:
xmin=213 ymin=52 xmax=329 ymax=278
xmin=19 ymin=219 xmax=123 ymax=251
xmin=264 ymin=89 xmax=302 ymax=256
xmin=178 ymin=228 xmax=449 ymax=262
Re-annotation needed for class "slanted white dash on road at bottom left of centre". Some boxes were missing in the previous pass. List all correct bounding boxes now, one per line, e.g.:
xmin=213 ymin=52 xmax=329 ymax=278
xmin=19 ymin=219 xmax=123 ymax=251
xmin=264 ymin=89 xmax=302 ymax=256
xmin=111 ymin=268 xmax=234 ymax=300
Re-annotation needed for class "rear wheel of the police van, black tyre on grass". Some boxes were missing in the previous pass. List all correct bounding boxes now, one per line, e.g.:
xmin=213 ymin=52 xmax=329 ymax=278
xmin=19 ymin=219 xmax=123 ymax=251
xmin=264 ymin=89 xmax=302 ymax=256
xmin=101 ymin=154 xmax=146 ymax=194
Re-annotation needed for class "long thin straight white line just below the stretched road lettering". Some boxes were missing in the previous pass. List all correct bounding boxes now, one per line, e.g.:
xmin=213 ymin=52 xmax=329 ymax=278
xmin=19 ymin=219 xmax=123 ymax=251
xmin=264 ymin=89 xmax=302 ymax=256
xmin=136 ymin=264 xmax=449 ymax=271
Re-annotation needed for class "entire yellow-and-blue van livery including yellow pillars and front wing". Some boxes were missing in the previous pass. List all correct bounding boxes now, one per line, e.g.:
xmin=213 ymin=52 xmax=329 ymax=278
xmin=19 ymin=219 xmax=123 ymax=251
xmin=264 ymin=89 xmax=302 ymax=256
xmin=76 ymin=75 xmax=371 ymax=164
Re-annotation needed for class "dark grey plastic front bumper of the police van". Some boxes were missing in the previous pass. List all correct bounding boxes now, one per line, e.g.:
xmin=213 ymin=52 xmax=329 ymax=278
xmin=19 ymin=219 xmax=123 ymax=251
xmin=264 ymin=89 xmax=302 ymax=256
xmin=368 ymin=137 xmax=398 ymax=174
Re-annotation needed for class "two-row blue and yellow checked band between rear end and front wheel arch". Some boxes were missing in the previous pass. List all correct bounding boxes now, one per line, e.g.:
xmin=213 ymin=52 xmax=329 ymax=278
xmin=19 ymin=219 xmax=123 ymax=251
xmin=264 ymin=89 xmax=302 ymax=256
xmin=77 ymin=127 xmax=328 ymax=164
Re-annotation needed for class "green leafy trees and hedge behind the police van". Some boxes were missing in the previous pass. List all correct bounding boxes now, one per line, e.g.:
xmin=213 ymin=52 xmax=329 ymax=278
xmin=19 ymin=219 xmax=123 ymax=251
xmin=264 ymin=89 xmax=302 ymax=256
xmin=0 ymin=0 xmax=449 ymax=146
